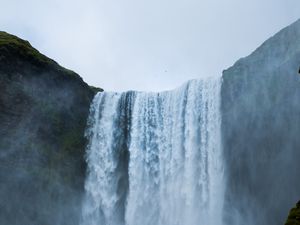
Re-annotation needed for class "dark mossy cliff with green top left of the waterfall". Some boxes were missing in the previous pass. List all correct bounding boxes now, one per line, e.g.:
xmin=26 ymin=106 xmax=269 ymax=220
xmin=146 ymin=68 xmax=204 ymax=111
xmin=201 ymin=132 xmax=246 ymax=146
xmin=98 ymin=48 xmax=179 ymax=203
xmin=0 ymin=32 xmax=101 ymax=225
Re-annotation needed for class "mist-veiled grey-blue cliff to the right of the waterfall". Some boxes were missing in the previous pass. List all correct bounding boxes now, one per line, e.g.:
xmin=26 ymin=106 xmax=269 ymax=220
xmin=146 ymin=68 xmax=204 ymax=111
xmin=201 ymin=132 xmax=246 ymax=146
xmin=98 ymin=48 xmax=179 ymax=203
xmin=222 ymin=21 xmax=300 ymax=225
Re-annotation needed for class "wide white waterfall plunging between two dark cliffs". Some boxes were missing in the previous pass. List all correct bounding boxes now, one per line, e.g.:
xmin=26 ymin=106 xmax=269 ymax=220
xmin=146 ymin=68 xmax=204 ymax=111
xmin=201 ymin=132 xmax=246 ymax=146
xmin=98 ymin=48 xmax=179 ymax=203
xmin=81 ymin=78 xmax=224 ymax=225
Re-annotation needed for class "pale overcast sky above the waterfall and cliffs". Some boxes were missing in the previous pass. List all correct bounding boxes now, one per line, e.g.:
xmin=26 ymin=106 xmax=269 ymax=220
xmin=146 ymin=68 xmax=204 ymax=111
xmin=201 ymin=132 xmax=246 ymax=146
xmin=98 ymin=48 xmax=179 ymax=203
xmin=0 ymin=0 xmax=300 ymax=91
